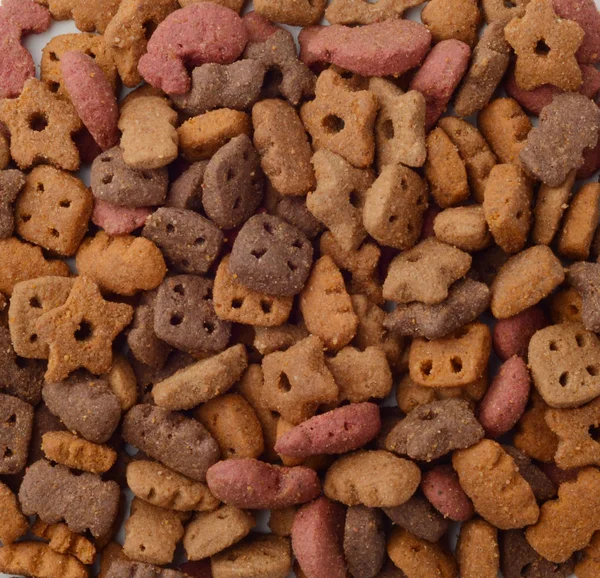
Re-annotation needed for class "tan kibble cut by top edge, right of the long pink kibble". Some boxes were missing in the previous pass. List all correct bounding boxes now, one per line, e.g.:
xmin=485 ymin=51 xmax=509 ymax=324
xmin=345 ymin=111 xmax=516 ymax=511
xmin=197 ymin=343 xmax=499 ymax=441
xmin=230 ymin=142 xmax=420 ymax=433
xmin=421 ymin=0 xmax=481 ymax=47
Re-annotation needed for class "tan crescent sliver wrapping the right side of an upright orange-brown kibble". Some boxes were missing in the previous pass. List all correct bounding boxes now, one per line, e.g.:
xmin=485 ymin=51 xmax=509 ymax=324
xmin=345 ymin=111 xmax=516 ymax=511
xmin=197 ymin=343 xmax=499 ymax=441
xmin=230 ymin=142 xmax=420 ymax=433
xmin=438 ymin=116 xmax=497 ymax=203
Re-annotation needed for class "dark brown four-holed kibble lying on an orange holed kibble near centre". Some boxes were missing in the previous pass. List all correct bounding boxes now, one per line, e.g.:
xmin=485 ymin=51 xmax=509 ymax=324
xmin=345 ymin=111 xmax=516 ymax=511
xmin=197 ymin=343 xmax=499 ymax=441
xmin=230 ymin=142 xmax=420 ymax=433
xmin=229 ymin=215 xmax=313 ymax=296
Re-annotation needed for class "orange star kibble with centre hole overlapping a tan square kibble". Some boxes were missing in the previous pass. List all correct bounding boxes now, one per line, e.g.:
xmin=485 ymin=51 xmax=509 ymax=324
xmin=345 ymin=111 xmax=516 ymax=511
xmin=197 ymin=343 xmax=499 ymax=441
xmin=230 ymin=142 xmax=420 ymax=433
xmin=36 ymin=277 xmax=133 ymax=381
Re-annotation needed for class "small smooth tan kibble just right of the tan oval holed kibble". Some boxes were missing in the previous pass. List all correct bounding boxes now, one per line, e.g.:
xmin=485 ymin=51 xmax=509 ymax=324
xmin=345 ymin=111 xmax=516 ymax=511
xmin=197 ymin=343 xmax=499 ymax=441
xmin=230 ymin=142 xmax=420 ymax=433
xmin=433 ymin=205 xmax=492 ymax=251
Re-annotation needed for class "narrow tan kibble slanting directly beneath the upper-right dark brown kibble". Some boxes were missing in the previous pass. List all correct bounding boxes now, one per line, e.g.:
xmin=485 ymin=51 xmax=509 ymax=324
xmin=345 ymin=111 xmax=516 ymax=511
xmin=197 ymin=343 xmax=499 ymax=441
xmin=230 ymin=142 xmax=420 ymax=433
xmin=531 ymin=170 xmax=576 ymax=245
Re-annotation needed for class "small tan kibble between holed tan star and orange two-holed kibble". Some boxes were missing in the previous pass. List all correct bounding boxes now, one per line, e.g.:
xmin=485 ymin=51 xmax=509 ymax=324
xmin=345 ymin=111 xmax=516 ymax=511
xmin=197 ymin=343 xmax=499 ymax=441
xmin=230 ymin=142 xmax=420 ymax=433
xmin=326 ymin=346 xmax=392 ymax=403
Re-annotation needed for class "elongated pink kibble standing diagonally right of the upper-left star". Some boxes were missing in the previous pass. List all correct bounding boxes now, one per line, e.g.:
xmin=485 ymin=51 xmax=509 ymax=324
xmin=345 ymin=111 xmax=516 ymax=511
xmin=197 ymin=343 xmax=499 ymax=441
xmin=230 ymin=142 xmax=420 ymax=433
xmin=60 ymin=52 xmax=119 ymax=150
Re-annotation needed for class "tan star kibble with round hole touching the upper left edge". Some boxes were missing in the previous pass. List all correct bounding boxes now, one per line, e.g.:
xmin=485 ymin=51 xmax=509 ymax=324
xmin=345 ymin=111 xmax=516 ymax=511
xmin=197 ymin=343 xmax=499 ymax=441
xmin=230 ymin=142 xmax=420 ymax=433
xmin=0 ymin=78 xmax=83 ymax=171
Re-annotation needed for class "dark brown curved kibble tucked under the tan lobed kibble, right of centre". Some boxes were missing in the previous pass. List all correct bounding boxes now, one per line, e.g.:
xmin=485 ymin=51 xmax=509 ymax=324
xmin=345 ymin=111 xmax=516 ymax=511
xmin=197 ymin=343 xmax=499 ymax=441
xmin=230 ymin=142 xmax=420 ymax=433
xmin=384 ymin=278 xmax=490 ymax=339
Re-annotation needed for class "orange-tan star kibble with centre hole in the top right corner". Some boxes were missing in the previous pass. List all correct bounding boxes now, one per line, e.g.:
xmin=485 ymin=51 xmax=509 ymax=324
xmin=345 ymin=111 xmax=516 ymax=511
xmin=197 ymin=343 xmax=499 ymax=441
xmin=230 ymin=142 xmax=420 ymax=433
xmin=504 ymin=0 xmax=584 ymax=91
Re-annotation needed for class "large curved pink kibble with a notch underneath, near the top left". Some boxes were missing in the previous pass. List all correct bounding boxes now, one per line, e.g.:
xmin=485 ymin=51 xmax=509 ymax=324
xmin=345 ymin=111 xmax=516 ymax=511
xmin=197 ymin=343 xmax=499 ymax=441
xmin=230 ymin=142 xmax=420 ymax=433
xmin=138 ymin=2 xmax=248 ymax=94
